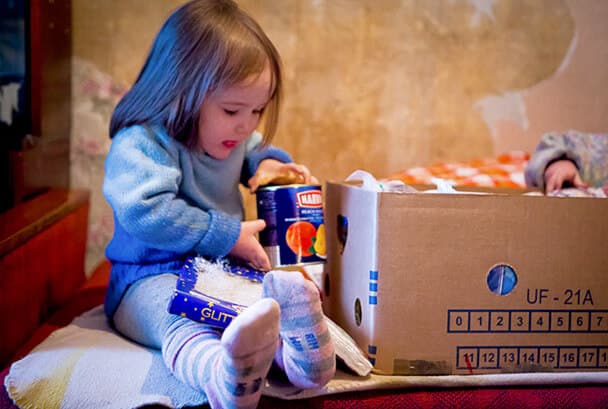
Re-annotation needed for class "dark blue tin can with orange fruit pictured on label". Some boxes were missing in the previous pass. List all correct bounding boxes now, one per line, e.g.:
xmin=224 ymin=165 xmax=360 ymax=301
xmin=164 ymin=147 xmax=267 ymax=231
xmin=256 ymin=185 xmax=326 ymax=268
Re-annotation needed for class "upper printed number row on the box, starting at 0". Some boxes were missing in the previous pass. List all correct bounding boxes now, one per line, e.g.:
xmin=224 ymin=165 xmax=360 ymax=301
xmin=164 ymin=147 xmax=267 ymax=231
xmin=448 ymin=310 xmax=608 ymax=333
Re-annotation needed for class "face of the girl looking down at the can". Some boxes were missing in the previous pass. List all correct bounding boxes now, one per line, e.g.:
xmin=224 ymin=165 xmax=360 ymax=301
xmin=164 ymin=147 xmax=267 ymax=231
xmin=197 ymin=65 xmax=271 ymax=159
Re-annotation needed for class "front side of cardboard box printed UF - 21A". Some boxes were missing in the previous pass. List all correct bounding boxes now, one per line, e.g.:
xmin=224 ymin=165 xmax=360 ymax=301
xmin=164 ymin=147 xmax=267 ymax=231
xmin=375 ymin=195 xmax=608 ymax=374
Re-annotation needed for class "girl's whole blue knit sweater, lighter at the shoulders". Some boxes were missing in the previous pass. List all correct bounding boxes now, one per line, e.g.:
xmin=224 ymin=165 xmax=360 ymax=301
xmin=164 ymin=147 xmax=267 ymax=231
xmin=103 ymin=126 xmax=291 ymax=320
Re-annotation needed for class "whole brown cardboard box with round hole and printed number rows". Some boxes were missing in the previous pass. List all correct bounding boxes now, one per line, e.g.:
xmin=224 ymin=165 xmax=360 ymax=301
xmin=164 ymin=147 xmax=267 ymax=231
xmin=324 ymin=182 xmax=608 ymax=375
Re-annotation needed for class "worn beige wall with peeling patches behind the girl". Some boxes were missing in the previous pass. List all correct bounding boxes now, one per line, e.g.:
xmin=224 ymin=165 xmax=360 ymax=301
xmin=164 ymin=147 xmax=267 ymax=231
xmin=72 ymin=0 xmax=608 ymax=272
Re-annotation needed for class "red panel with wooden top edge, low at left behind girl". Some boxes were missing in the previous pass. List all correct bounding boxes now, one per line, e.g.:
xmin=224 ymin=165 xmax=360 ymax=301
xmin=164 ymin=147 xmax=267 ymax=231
xmin=0 ymin=190 xmax=89 ymax=365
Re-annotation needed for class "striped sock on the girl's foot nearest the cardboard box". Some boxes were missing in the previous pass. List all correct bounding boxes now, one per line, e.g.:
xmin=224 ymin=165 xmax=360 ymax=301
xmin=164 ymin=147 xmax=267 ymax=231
xmin=263 ymin=270 xmax=336 ymax=388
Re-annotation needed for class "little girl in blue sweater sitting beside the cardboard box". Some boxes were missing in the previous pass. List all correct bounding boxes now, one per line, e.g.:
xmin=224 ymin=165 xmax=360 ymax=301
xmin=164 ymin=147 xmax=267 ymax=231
xmin=103 ymin=0 xmax=335 ymax=408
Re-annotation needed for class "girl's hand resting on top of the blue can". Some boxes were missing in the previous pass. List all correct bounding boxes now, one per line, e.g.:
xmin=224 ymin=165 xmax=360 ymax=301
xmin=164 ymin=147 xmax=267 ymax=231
xmin=247 ymin=159 xmax=319 ymax=193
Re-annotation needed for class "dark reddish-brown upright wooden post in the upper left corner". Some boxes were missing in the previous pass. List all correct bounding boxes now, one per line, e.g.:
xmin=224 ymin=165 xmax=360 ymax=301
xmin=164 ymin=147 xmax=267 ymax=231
xmin=2 ymin=0 xmax=72 ymax=204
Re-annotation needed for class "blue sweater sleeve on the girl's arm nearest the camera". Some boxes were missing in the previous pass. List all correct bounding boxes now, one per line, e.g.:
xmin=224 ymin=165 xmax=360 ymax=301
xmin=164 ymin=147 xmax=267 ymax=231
xmin=103 ymin=127 xmax=240 ymax=256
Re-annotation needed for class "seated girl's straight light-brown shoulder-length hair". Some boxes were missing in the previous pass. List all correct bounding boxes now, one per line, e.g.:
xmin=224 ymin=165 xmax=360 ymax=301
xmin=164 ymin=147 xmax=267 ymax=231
xmin=110 ymin=0 xmax=282 ymax=146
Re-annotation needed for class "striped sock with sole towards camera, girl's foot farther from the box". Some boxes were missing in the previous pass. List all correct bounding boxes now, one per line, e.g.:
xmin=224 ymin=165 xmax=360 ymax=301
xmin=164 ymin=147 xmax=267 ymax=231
xmin=163 ymin=299 xmax=280 ymax=409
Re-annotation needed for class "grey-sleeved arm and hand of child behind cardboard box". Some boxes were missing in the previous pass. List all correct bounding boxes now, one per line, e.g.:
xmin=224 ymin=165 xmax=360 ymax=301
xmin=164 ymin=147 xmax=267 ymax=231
xmin=525 ymin=131 xmax=608 ymax=194
